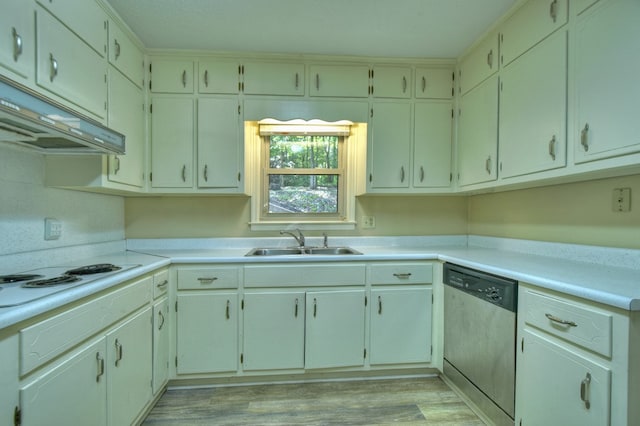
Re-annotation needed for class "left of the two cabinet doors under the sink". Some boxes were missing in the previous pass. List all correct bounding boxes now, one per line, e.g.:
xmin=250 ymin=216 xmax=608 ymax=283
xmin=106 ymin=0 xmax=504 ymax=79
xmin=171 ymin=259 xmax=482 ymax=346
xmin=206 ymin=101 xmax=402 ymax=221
xmin=243 ymin=291 xmax=305 ymax=370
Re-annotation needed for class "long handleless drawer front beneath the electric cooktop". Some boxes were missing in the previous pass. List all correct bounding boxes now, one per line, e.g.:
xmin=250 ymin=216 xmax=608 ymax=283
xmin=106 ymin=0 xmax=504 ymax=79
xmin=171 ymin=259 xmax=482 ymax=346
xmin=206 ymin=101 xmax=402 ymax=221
xmin=20 ymin=277 xmax=152 ymax=375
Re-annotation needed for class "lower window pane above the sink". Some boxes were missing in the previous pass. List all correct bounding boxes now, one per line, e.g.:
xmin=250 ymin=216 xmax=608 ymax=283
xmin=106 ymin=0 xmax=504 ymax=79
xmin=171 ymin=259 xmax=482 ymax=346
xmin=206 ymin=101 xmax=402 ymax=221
xmin=269 ymin=175 xmax=338 ymax=213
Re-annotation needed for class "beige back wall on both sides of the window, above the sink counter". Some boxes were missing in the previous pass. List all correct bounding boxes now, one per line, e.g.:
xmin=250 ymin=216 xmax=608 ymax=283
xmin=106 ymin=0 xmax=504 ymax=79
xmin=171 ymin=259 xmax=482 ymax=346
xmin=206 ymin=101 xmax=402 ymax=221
xmin=125 ymin=197 xmax=467 ymax=238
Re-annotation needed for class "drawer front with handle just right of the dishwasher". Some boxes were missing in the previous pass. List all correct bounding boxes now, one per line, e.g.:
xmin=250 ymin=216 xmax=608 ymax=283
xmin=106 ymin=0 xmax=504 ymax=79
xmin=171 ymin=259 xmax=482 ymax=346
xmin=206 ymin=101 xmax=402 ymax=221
xmin=520 ymin=290 xmax=613 ymax=357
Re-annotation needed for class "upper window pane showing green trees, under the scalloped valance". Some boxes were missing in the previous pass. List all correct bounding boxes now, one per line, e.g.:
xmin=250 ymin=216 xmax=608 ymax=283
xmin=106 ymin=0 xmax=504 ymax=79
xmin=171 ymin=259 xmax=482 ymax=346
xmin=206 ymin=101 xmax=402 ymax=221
xmin=269 ymin=135 xmax=339 ymax=169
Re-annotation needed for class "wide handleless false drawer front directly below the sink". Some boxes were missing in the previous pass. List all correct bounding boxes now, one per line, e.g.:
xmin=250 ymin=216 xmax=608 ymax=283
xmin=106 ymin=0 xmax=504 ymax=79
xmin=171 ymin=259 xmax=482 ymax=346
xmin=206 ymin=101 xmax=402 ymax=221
xmin=244 ymin=263 xmax=365 ymax=287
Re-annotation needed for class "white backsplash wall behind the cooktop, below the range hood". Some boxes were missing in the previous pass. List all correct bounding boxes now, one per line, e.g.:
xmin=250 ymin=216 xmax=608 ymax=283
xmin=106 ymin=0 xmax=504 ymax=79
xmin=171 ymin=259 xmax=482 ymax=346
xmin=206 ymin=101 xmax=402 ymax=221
xmin=0 ymin=143 xmax=124 ymax=256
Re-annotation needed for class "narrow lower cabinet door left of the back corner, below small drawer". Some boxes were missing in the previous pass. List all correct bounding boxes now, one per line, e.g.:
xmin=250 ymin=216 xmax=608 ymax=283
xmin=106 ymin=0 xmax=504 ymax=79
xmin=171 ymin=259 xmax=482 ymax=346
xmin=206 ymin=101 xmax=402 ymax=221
xmin=153 ymin=297 xmax=169 ymax=395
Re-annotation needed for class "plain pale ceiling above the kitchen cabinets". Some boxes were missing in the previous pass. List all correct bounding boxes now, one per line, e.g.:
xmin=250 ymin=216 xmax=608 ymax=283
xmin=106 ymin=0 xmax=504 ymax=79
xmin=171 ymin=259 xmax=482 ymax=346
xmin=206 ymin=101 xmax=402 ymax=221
xmin=107 ymin=0 xmax=517 ymax=58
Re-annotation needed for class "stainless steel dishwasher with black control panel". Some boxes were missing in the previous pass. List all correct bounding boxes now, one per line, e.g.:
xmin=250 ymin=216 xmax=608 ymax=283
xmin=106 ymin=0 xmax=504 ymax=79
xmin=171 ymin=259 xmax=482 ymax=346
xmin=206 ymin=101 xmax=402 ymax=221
xmin=443 ymin=263 xmax=518 ymax=426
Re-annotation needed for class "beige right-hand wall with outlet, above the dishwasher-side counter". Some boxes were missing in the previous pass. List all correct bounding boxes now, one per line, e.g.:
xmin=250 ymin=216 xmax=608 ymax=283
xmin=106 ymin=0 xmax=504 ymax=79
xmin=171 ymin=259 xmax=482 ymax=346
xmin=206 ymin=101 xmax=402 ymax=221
xmin=468 ymin=175 xmax=640 ymax=249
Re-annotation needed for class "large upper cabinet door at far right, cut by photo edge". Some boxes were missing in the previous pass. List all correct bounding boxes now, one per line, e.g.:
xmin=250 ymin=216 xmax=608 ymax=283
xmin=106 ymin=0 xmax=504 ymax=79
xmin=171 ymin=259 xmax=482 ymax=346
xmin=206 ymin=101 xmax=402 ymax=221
xmin=573 ymin=0 xmax=640 ymax=163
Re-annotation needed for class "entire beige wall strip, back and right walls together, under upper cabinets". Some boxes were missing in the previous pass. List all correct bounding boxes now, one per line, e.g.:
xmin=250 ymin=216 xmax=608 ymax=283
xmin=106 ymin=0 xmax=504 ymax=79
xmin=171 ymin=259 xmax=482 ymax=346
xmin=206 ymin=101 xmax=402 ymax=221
xmin=125 ymin=175 xmax=640 ymax=249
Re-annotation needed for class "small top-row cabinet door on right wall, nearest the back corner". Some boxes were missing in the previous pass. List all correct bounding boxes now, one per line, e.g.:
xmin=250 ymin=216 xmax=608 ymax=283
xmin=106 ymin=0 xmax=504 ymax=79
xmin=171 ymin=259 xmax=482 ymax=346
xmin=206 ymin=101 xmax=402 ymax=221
xmin=459 ymin=34 xmax=498 ymax=95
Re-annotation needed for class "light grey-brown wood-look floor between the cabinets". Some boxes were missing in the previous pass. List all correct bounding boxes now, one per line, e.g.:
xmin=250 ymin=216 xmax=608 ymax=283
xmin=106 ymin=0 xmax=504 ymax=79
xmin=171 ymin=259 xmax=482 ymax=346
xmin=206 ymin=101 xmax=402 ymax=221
xmin=143 ymin=377 xmax=484 ymax=426
